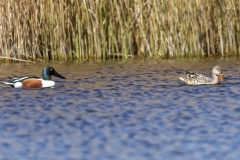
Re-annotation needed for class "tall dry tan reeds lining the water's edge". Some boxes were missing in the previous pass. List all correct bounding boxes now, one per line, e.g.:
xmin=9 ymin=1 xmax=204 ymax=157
xmin=0 ymin=0 xmax=240 ymax=61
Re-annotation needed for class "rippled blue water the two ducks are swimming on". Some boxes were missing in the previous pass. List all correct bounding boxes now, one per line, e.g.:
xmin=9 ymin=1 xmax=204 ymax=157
xmin=0 ymin=59 xmax=240 ymax=160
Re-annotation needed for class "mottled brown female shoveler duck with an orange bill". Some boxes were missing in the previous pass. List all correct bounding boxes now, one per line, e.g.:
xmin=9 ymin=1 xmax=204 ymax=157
xmin=179 ymin=65 xmax=226 ymax=85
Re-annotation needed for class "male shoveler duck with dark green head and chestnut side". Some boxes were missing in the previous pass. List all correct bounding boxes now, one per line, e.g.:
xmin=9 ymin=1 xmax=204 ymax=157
xmin=3 ymin=67 xmax=66 ymax=88
